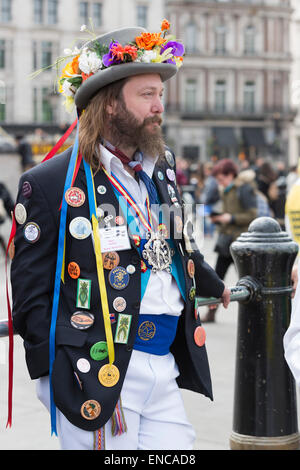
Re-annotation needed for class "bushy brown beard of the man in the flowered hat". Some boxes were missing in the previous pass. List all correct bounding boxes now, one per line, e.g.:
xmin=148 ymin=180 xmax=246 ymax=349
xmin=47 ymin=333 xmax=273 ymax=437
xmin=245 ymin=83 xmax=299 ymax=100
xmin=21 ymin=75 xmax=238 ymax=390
xmin=109 ymin=98 xmax=165 ymax=158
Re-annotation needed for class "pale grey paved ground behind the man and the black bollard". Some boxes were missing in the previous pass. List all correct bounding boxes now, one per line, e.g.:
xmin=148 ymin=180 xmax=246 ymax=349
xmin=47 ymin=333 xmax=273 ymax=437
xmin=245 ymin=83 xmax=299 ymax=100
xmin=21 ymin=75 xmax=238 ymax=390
xmin=0 ymin=155 xmax=298 ymax=450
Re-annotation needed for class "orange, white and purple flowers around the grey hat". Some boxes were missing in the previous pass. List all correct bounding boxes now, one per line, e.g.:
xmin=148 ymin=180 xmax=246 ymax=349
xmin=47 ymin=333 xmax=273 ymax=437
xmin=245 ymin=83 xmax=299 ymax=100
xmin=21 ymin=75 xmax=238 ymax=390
xmin=32 ymin=19 xmax=184 ymax=110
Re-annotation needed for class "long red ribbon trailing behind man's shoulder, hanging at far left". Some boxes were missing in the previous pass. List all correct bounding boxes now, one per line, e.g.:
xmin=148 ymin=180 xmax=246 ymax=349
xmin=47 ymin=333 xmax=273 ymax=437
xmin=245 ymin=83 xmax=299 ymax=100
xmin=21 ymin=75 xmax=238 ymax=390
xmin=5 ymin=119 xmax=82 ymax=427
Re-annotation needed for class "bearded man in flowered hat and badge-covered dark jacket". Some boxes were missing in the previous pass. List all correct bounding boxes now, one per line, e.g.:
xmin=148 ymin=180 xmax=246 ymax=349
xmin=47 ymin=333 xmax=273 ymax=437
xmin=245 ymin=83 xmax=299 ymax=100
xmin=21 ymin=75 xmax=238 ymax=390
xmin=11 ymin=23 xmax=229 ymax=450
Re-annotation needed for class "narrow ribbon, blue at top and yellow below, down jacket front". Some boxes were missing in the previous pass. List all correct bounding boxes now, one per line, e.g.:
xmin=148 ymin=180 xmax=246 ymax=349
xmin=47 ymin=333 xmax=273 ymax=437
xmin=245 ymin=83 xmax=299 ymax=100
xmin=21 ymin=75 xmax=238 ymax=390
xmin=83 ymin=159 xmax=115 ymax=364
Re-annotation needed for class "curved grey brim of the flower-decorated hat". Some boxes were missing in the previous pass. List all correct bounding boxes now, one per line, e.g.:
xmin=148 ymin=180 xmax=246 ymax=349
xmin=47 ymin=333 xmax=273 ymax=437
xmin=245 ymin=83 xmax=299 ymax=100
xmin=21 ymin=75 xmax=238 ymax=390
xmin=75 ymin=62 xmax=178 ymax=111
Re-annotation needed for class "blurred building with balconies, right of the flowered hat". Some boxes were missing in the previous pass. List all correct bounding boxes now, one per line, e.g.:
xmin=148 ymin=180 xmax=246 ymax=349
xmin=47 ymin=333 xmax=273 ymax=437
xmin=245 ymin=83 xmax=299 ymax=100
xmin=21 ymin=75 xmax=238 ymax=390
xmin=166 ymin=0 xmax=295 ymax=165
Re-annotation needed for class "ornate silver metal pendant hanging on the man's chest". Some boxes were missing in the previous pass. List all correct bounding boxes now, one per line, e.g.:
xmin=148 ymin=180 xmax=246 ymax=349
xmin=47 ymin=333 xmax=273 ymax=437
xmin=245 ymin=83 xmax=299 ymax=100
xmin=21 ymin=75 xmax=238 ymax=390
xmin=142 ymin=231 xmax=174 ymax=273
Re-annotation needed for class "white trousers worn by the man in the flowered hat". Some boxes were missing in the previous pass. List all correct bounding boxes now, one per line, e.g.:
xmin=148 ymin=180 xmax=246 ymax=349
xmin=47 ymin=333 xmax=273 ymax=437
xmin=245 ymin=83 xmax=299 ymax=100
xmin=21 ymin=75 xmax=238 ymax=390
xmin=37 ymin=350 xmax=195 ymax=450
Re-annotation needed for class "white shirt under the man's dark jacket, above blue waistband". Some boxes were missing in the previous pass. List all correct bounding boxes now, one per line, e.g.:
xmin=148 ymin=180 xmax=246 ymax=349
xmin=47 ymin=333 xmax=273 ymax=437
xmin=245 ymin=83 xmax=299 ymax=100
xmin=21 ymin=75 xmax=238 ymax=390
xmin=100 ymin=145 xmax=184 ymax=316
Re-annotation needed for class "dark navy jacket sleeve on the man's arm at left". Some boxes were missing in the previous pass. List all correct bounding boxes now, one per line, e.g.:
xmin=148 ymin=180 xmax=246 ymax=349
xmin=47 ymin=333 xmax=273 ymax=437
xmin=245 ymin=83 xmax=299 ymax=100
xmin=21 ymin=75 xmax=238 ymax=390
xmin=11 ymin=173 xmax=58 ymax=378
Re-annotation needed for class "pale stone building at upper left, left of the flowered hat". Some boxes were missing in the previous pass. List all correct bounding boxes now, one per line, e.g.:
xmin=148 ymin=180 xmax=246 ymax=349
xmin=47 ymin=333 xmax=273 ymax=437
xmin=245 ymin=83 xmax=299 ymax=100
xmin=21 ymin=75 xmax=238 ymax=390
xmin=0 ymin=0 xmax=164 ymax=131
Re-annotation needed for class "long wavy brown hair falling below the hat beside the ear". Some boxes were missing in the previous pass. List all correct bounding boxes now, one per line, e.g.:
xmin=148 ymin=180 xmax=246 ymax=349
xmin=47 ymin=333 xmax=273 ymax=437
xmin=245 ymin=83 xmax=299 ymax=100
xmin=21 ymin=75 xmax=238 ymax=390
xmin=79 ymin=78 xmax=127 ymax=171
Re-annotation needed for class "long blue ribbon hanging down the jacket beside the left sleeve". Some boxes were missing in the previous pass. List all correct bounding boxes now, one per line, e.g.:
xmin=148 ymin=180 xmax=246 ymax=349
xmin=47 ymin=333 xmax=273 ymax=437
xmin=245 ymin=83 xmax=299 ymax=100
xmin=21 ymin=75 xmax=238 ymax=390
xmin=49 ymin=124 xmax=79 ymax=436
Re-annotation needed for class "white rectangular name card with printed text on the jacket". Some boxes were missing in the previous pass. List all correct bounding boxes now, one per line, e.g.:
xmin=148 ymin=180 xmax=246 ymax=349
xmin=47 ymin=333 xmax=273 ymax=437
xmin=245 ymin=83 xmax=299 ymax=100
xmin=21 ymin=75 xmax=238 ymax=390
xmin=99 ymin=225 xmax=130 ymax=253
